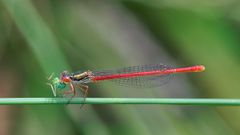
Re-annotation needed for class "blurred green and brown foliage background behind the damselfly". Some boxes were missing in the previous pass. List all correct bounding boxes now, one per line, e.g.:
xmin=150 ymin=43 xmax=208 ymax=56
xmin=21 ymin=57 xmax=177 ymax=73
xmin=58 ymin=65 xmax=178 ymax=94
xmin=0 ymin=0 xmax=240 ymax=135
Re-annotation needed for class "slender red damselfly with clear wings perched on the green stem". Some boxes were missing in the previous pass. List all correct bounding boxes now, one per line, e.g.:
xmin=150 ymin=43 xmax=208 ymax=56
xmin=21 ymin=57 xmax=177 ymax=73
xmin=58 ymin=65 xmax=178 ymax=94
xmin=47 ymin=64 xmax=205 ymax=99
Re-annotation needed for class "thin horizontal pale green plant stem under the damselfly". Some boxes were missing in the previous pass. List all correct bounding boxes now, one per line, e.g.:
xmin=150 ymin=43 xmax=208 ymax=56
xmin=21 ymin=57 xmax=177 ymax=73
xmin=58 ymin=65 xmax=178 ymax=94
xmin=0 ymin=98 xmax=240 ymax=106
